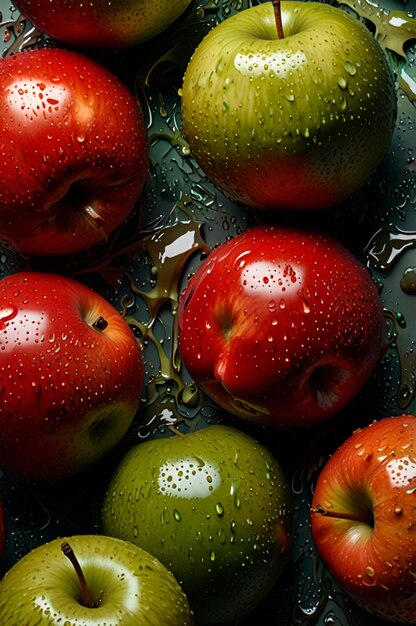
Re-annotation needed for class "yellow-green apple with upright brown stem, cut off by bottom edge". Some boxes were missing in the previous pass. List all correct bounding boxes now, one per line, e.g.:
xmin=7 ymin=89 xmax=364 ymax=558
xmin=0 ymin=535 xmax=193 ymax=626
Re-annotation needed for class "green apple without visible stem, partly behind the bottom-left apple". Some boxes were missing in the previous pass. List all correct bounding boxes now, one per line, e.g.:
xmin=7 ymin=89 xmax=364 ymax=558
xmin=102 ymin=425 xmax=292 ymax=624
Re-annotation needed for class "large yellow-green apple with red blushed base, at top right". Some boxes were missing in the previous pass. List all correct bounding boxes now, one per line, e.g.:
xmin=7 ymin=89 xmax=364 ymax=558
xmin=182 ymin=1 xmax=397 ymax=210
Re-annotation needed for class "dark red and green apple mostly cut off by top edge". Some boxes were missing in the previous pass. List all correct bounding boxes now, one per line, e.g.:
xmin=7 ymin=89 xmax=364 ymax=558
xmin=14 ymin=0 xmax=192 ymax=48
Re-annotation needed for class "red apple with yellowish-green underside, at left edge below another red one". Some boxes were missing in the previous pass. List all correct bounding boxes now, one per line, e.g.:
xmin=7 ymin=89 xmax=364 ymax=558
xmin=0 ymin=272 xmax=143 ymax=479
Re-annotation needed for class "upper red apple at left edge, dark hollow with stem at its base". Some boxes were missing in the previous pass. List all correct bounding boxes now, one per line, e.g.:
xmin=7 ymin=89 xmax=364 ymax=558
xmin=0 ymin=49 xmax=148 ymax=255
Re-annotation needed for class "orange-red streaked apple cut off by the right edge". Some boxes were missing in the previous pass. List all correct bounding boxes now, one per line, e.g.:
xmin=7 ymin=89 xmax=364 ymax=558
xmin=311 ymin=415 xmax=416 ymax=624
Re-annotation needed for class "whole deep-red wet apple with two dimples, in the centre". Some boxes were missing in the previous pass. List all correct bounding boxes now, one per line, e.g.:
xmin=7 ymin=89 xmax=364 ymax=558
xmin=178 ymin=226 xmax=386 ymax=427
